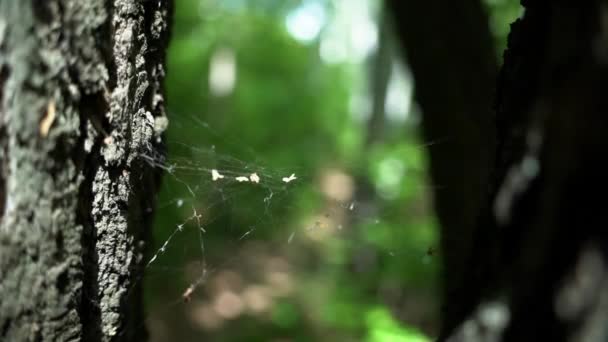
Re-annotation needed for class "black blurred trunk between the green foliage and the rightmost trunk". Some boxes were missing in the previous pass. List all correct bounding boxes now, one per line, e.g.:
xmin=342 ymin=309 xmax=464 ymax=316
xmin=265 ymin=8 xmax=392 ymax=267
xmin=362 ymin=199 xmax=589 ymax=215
xmin=387 ymin=0 xmax=498 ymax=336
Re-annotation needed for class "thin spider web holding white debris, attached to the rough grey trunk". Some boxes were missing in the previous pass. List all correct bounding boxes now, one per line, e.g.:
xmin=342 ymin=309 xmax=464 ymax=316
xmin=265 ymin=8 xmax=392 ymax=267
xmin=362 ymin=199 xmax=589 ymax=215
xmin=143 ymin=117 xmax=309 ymax=300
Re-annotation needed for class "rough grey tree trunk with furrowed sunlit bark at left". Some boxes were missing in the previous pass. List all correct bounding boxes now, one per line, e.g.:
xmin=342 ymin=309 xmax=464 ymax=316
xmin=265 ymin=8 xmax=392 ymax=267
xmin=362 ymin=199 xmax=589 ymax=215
xmin=0 ymin=0 xmax=170 ymax=341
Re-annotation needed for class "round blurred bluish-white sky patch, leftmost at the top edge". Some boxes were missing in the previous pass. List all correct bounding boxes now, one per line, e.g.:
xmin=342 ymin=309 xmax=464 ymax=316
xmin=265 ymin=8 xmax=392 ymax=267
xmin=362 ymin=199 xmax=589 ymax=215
xmin=285 ymin=0 xmax=327 ymax=43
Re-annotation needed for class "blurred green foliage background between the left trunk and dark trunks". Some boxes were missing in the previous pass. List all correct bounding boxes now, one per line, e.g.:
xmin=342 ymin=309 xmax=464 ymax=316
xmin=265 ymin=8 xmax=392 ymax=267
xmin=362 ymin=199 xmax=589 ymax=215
xmin=146 ymin=0 xmax=439 ymax=341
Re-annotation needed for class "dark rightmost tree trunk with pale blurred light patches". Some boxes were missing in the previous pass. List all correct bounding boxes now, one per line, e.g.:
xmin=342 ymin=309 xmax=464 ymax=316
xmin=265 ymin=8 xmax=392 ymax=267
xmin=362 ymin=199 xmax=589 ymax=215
xmin=392 ymin=1 xmax=608 ymax=341
